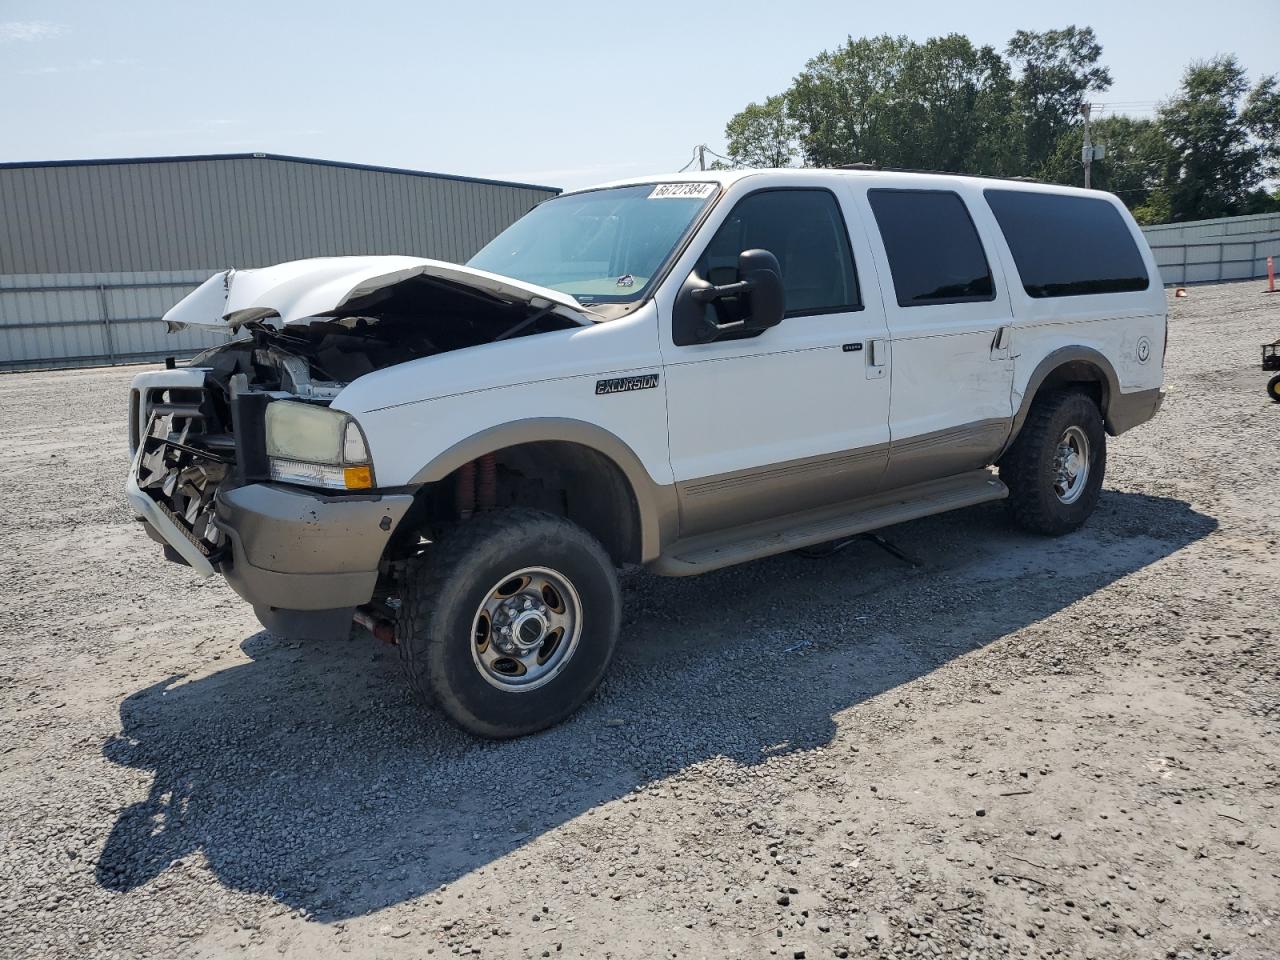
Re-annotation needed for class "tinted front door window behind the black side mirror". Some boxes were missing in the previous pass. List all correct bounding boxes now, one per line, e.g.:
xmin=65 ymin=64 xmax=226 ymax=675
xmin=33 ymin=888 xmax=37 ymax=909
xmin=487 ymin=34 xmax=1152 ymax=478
xmin=695 ymin=189 xmax=861 ymax=316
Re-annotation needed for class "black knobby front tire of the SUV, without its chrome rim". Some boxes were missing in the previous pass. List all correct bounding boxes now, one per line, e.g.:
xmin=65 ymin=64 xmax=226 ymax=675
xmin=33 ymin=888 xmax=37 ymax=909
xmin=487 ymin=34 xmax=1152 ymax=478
xmin=396 ymin=508 xmax=622 ymax=740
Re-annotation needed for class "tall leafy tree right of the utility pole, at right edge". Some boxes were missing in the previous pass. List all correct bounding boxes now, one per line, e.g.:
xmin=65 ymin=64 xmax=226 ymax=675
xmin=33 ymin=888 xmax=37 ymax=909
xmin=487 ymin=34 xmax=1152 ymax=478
xmin=1158 ymin=56 xmax=1280 ymax=220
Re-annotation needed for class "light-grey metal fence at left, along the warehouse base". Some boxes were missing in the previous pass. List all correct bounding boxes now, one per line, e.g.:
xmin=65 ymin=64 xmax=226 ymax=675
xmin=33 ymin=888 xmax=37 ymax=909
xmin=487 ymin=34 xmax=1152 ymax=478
xmin=0 ymin=270 xmax=228 ymax=370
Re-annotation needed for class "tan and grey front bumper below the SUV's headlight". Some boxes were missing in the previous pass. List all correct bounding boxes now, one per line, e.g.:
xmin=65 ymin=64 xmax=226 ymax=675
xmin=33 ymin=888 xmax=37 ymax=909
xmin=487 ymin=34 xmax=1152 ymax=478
xmin=214 ymin=484 xmax=413 ymax=611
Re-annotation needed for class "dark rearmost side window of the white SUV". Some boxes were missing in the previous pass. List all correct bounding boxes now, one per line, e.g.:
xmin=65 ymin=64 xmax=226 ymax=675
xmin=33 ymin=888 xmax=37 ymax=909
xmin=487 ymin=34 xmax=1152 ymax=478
xmin=984 ymin=189 xmax=1151 ymax=297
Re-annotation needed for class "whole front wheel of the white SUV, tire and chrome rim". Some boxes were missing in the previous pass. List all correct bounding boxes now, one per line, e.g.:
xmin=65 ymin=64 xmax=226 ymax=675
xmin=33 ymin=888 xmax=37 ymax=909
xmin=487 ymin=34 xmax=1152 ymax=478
xmin=396 ymin=509 xmax=621 ymax=739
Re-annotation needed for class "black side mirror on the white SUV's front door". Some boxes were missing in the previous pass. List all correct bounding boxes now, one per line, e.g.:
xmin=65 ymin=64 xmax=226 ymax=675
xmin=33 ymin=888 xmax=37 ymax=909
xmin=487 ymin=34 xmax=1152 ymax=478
xmin=671 ymin=250 xmax=786 ymax=347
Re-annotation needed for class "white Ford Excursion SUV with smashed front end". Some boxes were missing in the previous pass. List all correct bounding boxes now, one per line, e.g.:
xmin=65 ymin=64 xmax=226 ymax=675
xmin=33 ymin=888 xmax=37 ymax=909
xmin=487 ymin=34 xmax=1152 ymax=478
xmin=128 ymin=170 xmax=1166 ymax=737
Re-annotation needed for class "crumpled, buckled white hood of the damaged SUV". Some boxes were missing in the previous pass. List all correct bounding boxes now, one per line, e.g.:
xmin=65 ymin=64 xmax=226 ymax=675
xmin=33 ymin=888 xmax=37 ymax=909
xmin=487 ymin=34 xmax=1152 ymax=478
xmin=164 ymin=256 xmax=602 ymax=330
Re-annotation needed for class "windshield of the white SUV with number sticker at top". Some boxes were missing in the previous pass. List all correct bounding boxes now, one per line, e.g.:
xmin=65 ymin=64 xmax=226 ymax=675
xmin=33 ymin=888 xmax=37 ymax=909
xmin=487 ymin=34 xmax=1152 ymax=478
xmin=467 ymin=183 xmax=719 ymax=305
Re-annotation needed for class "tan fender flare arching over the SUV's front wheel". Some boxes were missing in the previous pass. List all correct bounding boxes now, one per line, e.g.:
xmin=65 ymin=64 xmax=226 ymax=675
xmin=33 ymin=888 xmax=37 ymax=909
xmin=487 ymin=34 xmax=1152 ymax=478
xmin=408 ymin=417 xmax=680 ymax=563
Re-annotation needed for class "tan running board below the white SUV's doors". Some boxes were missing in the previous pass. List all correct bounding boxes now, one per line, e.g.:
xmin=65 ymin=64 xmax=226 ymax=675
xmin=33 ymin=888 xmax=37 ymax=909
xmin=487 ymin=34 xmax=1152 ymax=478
xmin=650 ymin=470 xmax=1009 ymax=577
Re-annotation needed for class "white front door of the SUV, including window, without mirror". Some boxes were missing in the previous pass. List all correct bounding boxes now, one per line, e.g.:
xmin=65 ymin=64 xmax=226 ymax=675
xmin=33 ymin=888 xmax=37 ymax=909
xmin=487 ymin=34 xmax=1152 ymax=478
xmin=660 ymin=184 xmax=890 ymax=538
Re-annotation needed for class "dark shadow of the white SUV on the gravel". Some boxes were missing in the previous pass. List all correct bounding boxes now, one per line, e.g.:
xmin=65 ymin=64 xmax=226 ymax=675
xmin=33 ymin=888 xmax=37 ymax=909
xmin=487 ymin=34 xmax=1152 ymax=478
xmin=97 ymin=492 xmax=1217 ymax=920
